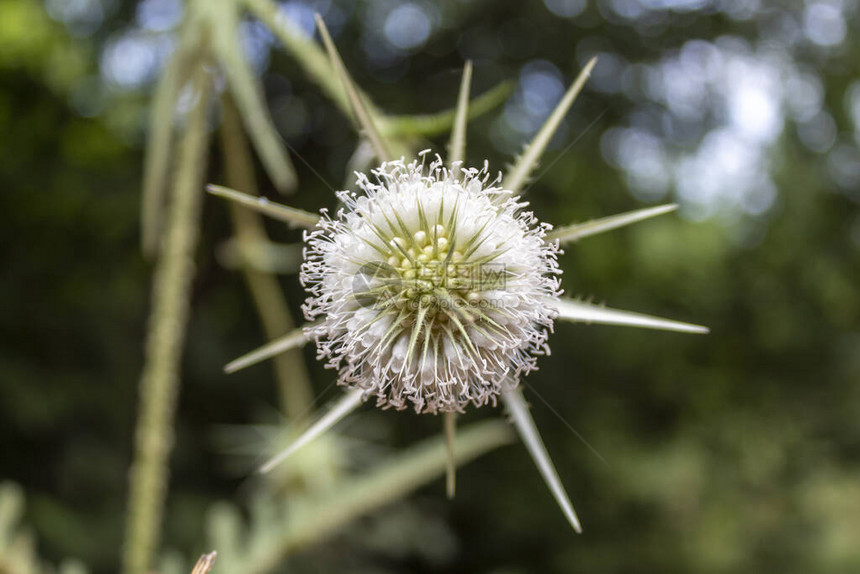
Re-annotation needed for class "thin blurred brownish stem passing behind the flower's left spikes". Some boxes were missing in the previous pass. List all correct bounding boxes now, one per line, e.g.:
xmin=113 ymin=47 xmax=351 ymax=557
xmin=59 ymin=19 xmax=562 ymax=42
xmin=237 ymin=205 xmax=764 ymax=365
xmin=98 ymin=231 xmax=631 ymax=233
xmin=221 ymin=95 xmax=313 ymax=423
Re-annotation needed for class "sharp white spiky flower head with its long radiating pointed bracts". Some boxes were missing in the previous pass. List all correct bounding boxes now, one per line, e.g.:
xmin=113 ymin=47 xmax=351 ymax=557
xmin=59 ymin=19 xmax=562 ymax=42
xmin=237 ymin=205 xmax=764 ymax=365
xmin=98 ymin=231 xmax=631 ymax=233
xmin=209 ymin=17 xmax=707 ymax=531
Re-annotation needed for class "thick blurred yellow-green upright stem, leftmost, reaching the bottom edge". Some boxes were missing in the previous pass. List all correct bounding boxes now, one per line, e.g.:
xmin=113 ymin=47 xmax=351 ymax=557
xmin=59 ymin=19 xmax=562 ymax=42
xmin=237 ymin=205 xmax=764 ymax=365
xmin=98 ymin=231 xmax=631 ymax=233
xmin=123 ymin=62 xmax=211 ymax=574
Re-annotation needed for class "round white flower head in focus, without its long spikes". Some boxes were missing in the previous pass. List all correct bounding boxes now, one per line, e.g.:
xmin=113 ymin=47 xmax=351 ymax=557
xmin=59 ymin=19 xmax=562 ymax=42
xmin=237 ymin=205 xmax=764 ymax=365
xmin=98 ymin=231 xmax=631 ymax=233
xmin=301 ymin=157 xmax=561 ymax=413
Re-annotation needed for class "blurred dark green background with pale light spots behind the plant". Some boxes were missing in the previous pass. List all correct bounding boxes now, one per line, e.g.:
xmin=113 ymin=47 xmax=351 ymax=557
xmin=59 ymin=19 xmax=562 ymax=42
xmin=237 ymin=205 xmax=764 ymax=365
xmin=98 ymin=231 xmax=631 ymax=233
xmin=0 ymin=0 xmax=860 ymax=574
